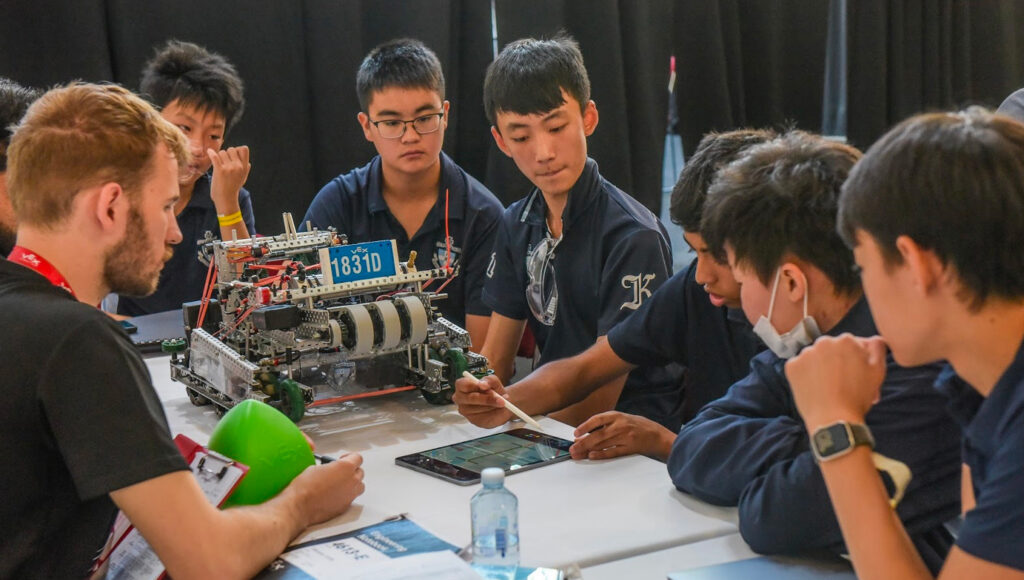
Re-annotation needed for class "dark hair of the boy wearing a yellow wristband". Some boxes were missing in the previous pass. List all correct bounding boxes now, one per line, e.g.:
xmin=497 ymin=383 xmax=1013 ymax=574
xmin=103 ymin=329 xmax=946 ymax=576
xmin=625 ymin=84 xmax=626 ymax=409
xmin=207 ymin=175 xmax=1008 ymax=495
xmin=139 ymin=40 xmax=246 ymax=131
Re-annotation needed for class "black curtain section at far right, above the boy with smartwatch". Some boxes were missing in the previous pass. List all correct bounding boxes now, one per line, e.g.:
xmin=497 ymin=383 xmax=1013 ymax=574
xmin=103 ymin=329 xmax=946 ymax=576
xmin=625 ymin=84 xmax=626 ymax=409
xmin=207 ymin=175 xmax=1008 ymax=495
xmin=847 ymin=0 xmax=1024 ymax=148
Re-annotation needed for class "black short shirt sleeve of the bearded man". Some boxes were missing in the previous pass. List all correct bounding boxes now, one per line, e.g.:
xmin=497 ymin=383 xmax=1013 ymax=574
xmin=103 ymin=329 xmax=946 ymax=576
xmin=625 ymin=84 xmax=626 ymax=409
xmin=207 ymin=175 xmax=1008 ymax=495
xmin=39 ymin=320 xmax=187 ymax=500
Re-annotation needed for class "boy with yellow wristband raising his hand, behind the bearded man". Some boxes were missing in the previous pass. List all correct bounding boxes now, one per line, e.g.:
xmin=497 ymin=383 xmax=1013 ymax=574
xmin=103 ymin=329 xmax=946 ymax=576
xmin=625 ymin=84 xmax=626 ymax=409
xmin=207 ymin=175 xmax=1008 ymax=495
xmin=117 ymin=40 xmax=255 ymax=317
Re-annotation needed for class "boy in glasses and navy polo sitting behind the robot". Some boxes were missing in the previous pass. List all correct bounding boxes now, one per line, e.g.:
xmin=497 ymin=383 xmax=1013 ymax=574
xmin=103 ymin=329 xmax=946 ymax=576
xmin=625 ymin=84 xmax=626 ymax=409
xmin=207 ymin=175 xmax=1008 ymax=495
xmin=302 ymin=39 xmax=503 ymax=349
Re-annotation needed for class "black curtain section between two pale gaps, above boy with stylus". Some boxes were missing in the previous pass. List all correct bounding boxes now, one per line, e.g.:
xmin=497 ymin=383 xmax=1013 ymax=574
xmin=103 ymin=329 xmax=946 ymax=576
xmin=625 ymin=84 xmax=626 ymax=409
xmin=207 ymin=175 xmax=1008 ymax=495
xmin=673 ymin=0 xmax=831 ymax=153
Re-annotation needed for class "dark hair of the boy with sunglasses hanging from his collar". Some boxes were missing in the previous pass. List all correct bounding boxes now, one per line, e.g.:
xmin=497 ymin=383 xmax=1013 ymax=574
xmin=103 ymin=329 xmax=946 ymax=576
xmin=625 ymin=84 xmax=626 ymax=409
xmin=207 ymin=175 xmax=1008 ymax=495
xmin=483 ymin=33 xmax=590 ymax=127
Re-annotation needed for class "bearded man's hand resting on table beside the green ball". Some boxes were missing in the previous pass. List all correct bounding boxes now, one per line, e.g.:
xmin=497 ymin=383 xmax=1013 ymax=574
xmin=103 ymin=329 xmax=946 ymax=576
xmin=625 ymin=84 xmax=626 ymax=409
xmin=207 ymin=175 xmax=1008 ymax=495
xmin=289 ymin=453 xmax=366 ymax=526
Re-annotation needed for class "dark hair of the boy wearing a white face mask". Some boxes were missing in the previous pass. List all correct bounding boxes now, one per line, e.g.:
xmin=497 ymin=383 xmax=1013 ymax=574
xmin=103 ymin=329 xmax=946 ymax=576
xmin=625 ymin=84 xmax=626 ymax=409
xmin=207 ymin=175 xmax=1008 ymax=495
xmin=700 ymin=131 xmax=860 ymax=294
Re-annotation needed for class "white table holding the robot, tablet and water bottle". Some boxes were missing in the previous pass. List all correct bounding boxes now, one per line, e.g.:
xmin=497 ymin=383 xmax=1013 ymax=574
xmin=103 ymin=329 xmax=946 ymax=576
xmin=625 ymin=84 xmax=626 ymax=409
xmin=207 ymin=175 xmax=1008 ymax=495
xmin=146 ymin=357 xmax=736 ymax=568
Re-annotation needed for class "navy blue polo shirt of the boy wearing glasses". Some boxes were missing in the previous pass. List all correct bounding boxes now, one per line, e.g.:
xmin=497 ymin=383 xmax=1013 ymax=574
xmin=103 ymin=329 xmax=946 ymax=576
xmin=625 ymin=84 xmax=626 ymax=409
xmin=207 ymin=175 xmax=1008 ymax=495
xmin=301 ymin=153 xmax=503 ymax=327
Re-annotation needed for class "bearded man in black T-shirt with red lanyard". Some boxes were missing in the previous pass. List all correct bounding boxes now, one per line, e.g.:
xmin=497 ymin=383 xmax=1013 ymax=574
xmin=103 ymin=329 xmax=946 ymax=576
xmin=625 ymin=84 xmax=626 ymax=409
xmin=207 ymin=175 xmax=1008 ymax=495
xmin=0 ymin=84 xmax=364 ymax=578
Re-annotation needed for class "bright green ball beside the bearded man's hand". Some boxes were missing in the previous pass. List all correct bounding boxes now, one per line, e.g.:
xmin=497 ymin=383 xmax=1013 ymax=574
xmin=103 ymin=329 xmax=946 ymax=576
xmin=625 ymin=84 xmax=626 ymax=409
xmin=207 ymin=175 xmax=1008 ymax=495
xmin=209 ymin=399 xmax=313 ymax=507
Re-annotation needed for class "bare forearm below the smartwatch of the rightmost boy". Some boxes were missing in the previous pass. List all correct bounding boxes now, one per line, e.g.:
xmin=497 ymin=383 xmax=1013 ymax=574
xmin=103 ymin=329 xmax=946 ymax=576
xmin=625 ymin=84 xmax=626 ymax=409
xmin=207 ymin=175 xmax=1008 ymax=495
xmin=821 ymin=447 xmax=932 ymax=580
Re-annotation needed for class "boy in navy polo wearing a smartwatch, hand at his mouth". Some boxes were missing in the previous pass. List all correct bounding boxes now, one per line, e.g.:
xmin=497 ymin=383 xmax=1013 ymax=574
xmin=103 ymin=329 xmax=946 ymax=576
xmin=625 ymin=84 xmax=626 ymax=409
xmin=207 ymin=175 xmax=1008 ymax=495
xmin=785 ymin=108 xmax=1024 ymax=579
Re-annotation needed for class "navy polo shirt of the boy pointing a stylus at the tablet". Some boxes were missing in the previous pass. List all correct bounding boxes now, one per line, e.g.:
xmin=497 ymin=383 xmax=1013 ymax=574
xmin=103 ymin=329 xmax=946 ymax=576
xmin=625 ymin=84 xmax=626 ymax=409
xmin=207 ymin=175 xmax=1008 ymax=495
xmin=608 ymin=260 xmax=765 ymax=430
